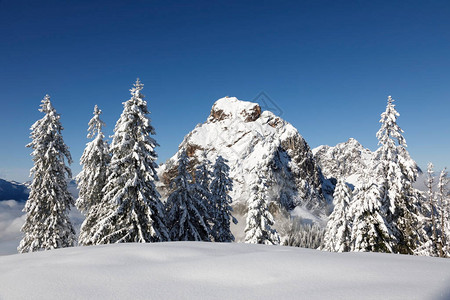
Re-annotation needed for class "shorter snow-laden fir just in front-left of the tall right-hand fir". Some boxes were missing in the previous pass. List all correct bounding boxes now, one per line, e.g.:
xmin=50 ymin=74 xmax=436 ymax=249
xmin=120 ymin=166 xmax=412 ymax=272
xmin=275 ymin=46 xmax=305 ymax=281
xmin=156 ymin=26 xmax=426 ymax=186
xmin=350 ymin=174 xmax=396 ymax=252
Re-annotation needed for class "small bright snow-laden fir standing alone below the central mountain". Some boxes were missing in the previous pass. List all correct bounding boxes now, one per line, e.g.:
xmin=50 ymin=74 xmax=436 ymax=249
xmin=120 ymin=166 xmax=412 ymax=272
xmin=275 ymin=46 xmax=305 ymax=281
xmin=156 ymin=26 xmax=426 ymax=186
xmin=245 ymin=166 xmax=280 ymax=245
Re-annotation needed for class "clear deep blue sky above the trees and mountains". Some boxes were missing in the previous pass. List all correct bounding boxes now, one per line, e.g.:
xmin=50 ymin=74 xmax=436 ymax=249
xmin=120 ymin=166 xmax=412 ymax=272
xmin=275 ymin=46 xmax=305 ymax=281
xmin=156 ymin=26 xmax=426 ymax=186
xmin=0 ymin=0 xmax=450 ymax=181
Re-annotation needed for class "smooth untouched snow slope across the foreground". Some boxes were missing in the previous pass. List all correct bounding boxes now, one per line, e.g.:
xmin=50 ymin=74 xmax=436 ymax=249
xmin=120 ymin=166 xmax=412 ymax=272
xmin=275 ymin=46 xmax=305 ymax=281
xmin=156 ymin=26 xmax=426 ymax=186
xmin=0 ymin=242 xmax=450 ymax=299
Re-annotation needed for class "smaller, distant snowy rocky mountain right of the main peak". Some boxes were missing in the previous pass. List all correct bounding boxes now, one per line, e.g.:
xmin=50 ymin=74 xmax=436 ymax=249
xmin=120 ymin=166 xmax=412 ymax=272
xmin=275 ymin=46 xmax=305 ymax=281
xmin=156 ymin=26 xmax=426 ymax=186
xmin=312 ymin=138 xmax=374 ymax=184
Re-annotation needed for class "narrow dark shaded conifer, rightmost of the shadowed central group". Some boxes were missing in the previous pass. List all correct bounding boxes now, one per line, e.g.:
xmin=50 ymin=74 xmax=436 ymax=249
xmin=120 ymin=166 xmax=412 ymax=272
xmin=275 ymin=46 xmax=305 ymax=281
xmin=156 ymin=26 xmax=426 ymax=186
xmin=211 ymin=156 xmax=237 ymax=242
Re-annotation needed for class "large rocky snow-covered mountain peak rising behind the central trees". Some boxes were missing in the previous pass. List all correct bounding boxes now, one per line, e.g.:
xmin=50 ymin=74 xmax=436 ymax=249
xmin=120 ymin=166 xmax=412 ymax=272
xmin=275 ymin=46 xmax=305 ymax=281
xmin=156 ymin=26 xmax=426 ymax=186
xmin=158 ymin=97 xmax=328 ymax=231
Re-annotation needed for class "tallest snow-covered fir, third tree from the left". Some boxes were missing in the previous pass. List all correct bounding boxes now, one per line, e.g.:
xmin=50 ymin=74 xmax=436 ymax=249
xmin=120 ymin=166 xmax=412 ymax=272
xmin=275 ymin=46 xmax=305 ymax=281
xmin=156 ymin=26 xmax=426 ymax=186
xmin=86 ymin=79 xmax=169 ymax=244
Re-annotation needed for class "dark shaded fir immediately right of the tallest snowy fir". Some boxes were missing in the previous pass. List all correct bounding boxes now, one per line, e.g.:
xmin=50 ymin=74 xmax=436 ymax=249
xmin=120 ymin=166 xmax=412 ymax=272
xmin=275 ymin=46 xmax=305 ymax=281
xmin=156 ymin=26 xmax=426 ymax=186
xmin=166 ymin=151 xmax=211 ymax=241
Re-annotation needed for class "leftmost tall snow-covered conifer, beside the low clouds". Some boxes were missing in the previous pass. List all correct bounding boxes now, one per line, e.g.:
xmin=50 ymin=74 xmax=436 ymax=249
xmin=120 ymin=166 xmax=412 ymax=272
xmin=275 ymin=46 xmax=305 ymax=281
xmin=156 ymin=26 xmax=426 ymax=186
xmin=17 ymin=95 xmax=75 ymax=253
